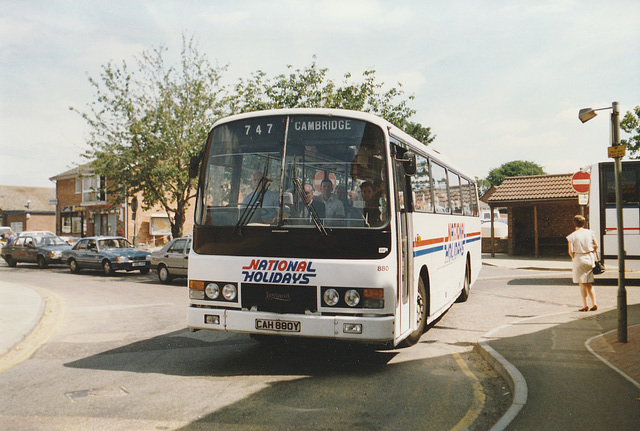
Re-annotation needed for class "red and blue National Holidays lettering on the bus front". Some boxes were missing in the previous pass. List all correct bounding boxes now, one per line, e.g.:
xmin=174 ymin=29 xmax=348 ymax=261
xmin=242 ymin=259 xmax=316 ymax=285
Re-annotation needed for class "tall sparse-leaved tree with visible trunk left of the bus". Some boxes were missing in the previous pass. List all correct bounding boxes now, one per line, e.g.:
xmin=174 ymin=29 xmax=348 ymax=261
xmin=70 ymin=37 xmax=225 ymax=237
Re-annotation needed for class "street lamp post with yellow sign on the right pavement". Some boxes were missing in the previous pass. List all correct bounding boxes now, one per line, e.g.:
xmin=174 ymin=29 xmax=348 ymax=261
xmin=578 ymin=102 xmax=627 ymax=343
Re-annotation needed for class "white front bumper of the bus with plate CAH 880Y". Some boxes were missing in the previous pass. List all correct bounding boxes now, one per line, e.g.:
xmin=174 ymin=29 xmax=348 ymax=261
xmin=187 ymin=307 xmax=395 ymax=342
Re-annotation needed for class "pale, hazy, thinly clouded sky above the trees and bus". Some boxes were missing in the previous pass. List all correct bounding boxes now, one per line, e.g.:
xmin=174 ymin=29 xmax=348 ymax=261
xmin=0 ymin=0 xmax=640 ymax=187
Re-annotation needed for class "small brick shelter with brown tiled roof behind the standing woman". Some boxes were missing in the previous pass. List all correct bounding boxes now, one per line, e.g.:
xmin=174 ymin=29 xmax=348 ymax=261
xmin=487 ymin=174 xmax=588 ymax=257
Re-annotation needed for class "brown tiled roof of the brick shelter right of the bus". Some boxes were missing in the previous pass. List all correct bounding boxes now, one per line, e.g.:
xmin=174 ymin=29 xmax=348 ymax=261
xmin=488 ymin=174 xmax=578 ymax=204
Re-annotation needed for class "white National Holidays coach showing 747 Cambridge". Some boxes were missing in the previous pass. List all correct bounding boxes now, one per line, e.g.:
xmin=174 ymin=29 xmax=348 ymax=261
xmin=187 ymin=109 xmax=481 ymax=346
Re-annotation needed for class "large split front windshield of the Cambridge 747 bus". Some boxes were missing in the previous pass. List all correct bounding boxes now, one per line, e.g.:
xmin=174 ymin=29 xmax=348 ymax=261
xmin=196 ymin=115 xmax=389 ymax=233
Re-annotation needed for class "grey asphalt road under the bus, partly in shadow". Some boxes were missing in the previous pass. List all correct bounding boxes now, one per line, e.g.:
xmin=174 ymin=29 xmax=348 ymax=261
xmin=0 ymin=263 xmax=615 ymax=430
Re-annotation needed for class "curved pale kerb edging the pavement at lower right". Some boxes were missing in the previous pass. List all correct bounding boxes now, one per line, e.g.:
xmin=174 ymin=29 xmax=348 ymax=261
xmin=473 ymin=337 xmax=528 ymax=431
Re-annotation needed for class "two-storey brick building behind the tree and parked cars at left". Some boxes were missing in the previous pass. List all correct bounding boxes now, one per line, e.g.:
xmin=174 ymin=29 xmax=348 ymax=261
xmin=50 ymin=164 xmax=193 ymax=248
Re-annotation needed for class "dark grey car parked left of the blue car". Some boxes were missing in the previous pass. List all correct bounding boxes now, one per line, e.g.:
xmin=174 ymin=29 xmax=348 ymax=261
xmin=1 ymin=232 xmax=71 ymax=268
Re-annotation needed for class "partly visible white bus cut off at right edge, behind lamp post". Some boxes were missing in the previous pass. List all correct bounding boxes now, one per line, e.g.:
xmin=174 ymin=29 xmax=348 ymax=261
xmin=586 ymin=160 xmax=640 ymax=270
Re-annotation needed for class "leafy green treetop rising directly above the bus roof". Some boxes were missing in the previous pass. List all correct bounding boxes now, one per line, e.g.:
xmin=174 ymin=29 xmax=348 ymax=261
xmin=227 ymin=61 xmax=435 ymax=145
